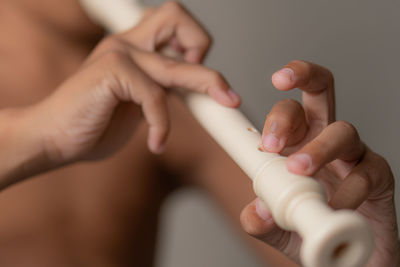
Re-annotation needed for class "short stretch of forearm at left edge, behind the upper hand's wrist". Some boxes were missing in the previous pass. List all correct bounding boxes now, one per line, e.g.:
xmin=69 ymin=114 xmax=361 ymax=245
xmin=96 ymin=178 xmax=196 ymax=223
xmin=0 ymin=109 xmax=52 ymax=190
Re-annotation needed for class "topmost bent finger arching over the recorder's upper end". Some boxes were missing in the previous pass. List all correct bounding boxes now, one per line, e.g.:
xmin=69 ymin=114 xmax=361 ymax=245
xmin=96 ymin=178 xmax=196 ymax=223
xmin=124 ymin=2 xmax=211 ymax=63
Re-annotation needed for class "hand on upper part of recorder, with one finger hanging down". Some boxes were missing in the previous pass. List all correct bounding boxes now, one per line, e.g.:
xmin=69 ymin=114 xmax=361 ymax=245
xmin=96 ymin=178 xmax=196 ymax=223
xmin=25 ymin=3 xmax=240 ymax=166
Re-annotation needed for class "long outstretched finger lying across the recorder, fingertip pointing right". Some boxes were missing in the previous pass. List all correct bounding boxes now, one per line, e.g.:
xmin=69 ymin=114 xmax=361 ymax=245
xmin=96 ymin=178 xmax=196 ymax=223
xmin=131 ymin=49 xmax=241 ymax=107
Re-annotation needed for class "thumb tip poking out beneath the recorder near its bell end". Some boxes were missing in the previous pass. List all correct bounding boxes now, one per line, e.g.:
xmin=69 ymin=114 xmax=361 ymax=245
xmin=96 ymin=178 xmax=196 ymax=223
xmin=240 ymin=198 xmax=296 ymax=257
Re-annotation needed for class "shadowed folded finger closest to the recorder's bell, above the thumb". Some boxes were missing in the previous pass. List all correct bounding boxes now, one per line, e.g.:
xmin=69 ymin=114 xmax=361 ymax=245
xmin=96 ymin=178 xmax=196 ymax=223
xmin=330 ymin=149 xmax=394 ymax=209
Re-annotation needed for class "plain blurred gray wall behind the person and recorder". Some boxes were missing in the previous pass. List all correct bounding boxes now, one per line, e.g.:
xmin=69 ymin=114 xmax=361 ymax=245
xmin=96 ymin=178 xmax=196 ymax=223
xmin=144 ymin=0 xmax=400 ymax=267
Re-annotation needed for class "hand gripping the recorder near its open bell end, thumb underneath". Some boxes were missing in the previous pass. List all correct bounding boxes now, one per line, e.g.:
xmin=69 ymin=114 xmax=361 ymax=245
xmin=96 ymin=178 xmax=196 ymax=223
xmin=241 ymin=61 xmax=400 ymax=267
